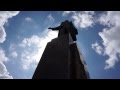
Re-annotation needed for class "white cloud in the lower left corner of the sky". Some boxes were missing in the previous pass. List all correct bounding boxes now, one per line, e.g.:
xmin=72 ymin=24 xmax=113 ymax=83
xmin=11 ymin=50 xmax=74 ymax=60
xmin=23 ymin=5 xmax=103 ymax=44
xmin=0 ymin=48 xmax=13 ymax=79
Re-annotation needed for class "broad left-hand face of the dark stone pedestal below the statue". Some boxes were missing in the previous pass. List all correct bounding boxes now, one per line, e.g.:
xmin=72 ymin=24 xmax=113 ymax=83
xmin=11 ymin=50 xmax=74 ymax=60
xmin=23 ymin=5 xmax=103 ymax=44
xmin=33 ymin=35 xmax=69 ymax=79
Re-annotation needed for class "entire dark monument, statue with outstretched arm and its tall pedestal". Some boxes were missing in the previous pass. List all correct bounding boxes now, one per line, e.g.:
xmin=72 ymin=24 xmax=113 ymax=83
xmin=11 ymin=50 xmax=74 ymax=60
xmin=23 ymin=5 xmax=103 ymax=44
xmin=32 ymin=20 xmax=89 ymax=79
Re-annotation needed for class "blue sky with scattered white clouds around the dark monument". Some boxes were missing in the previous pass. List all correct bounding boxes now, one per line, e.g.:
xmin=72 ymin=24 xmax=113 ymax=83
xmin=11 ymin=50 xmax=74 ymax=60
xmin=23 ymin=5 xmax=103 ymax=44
xmin=0 ymin=11 xmax=120 ymax=79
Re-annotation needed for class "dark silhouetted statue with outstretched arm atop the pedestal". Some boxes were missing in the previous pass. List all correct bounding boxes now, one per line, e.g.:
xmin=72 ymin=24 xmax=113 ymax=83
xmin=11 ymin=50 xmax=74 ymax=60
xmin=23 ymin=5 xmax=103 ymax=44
xmin=48 ymin=20 xmax=78 ymax=41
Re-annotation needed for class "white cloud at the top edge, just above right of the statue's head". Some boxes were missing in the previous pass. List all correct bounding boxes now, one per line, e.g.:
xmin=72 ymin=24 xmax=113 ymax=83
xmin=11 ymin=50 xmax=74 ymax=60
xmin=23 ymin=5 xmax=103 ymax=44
xmin=63 ymin=11 xmax=95 ymax=28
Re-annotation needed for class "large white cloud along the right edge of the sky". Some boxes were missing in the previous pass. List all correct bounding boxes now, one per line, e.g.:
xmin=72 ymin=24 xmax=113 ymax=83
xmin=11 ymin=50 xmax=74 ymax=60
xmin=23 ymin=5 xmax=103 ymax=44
xmin=93 ymin=11 xmax=120 ymax=69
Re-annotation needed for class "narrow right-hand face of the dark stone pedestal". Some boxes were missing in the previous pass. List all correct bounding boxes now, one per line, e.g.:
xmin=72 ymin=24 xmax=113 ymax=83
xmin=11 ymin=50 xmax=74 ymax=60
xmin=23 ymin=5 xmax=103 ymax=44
xmin=69 ymin=43 xmax=87 ymax=79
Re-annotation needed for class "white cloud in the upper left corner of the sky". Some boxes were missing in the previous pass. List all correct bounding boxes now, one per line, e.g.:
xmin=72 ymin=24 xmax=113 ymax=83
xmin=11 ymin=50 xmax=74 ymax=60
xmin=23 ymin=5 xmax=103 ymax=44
xmin=0 ymin=11 xmax=19 ymax=43
